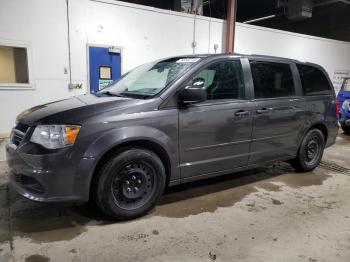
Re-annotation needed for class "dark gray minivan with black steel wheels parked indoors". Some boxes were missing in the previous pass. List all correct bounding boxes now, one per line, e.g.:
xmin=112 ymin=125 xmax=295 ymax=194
xmin=6 ymin=54 xmax=338 ymax=219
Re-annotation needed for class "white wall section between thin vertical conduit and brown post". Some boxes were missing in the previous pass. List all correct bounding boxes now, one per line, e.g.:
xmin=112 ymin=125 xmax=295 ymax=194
xmin=69 ymin=0 xmax=225 ymax=94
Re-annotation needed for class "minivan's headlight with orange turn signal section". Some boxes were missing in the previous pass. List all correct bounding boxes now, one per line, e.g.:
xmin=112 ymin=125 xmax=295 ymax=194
xmin=30 ymin=125 xmax=80 ymax=149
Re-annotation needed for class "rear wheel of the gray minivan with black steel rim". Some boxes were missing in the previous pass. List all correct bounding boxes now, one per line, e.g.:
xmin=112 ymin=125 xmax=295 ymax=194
xmin=290 ymin=129 xmax=325 ymax=172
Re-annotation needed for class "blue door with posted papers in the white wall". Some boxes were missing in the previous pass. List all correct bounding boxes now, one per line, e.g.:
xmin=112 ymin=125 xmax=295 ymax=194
xmin=89 ymin=46 xmax=121 ymax=93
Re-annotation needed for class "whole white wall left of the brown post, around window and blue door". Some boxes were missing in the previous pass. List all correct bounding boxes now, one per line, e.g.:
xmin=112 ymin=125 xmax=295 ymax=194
xmin=0 ymin=0 xmax=225 ymax=135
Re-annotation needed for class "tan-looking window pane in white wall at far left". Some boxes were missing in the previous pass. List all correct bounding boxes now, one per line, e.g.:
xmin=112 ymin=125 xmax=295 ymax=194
xmin=0 ymin=46 xmax=29 ymax=84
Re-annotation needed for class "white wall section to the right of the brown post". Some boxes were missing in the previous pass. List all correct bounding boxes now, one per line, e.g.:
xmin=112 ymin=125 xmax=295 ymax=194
xmin=235 ymin=23 xmax=350 ymax=89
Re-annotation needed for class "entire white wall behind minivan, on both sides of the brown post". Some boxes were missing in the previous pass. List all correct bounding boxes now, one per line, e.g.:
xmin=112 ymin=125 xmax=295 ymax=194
xmin=0 ymin=0 xmax=350 ymax=134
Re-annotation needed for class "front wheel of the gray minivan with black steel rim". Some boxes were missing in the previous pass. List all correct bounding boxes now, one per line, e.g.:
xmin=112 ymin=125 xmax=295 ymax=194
xmin=94 ymin=148 xmax=166 ymax=220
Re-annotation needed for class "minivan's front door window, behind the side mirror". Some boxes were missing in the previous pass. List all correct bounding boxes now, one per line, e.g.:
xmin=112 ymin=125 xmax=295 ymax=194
xmin=188 ymin=60 xmax=244 ymax=100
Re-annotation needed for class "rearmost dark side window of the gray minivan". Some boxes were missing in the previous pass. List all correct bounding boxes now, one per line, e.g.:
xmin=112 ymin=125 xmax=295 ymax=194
xmin=297 ymin=64 xmax=332 ymax=96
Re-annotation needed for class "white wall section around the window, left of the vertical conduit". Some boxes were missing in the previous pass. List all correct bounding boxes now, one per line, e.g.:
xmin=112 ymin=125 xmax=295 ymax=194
xmin=0 ymin=0 xmax=71 ymax=134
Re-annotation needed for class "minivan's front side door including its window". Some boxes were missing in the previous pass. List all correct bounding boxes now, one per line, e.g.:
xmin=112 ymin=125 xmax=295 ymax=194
xmin=179 ymin=60 xmax=254 ymax=179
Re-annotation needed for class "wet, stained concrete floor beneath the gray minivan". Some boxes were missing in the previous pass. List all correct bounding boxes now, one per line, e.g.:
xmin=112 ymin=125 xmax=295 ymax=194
xmin=0 ymin=134 xmax=350 ymax=262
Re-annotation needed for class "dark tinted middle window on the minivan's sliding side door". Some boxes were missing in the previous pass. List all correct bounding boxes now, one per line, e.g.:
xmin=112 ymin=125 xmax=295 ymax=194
xmin=250 ymin=61 xmax=295 ymax=98
